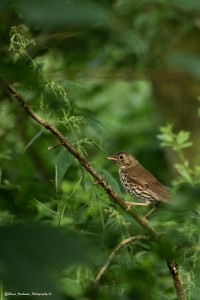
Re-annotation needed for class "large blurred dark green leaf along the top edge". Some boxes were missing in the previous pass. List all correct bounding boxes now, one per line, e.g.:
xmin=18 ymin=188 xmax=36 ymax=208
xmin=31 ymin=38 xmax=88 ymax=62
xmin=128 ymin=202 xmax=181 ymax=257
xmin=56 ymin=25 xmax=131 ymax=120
xmin=12 ymin=0 xmax=111 ymax=29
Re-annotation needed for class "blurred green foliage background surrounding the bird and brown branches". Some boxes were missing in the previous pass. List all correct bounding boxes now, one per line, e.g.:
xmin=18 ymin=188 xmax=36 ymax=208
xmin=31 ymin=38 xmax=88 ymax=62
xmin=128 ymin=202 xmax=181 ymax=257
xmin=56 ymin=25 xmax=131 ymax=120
xmin=0 ymin=0 xmax=200 ymax=300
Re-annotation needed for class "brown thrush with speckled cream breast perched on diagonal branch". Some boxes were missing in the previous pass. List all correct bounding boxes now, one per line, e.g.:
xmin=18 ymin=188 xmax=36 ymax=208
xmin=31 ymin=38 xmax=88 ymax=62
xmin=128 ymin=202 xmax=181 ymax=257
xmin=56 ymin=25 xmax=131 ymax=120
xmin=106 ymin=152 xmax=171 ymax=217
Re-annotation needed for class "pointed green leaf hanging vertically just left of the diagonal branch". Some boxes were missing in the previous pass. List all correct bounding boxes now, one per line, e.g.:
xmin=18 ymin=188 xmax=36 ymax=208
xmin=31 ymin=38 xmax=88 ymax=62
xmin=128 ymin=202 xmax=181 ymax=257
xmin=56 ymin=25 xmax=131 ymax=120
xmin=55 ymin=148 xmax=74 ymax=192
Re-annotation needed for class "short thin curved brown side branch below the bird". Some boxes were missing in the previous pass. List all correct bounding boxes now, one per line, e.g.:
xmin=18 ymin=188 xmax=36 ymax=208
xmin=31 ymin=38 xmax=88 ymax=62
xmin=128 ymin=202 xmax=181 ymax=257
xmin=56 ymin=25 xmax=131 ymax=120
xmin=96 ymin=235 xmax=151 ymax=283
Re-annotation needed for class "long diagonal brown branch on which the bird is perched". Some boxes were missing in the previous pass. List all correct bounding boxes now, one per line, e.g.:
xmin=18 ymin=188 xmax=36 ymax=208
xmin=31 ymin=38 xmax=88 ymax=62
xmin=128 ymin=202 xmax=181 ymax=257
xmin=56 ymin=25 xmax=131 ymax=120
xmin=3 ymin=76 xmax=185 ymax=300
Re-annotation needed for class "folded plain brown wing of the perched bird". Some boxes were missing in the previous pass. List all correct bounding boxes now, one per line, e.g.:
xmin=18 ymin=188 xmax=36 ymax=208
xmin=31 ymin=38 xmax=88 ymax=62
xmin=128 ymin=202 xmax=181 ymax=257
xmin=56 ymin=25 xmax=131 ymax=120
xmin=129 ymin=165 xmax=171 ymax=201
